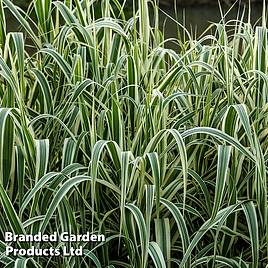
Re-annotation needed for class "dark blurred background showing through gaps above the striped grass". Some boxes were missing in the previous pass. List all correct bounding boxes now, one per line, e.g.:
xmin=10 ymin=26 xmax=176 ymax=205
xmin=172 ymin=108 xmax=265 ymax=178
xmin=7 ymin=0 xmax=263 ymax=42
